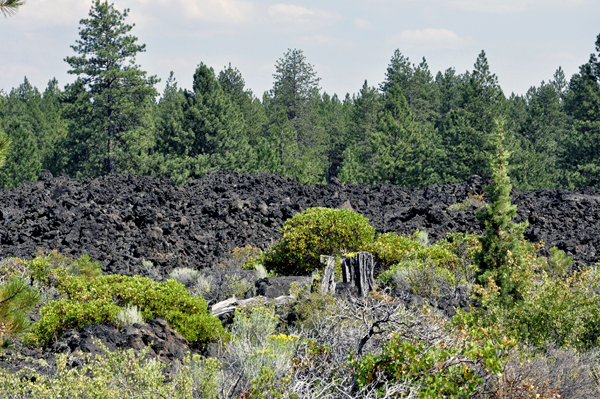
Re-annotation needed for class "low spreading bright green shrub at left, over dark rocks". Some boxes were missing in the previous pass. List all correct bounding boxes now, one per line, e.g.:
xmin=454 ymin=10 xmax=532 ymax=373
xmin=28 ymin=258 xmax=224 ymax=345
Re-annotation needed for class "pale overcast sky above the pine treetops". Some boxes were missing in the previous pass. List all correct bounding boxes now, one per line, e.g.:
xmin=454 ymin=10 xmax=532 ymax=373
xmin=0 ymin=0 xmax=600 ymax=97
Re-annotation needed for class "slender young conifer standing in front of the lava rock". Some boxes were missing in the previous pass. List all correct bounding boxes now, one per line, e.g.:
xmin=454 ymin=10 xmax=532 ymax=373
xmin=475 ymin=122 xmax=528 ymax=302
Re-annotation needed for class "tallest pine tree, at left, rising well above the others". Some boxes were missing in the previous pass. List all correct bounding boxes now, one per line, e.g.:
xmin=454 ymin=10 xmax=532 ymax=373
xmin=63 ymin=0 xmax=157 ymax=177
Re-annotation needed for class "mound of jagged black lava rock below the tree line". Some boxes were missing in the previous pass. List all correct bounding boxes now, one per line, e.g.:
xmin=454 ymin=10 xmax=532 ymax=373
xmin=0 ymin=172 xmax=600 ymax=276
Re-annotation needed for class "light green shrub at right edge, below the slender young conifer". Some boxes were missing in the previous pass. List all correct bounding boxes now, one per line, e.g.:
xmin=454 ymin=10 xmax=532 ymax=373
xmin=463 ymin=269 xmax=600 ymax=350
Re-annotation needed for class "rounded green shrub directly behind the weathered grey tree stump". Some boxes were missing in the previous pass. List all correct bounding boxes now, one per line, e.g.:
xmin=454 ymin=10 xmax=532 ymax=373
xmin=265 ymin=208 xmax=375 ymax=275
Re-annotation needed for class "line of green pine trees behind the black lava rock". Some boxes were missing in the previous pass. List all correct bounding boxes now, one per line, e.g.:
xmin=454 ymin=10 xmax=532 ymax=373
xmin=0 ymin=0 xmax=600 ymax=189
